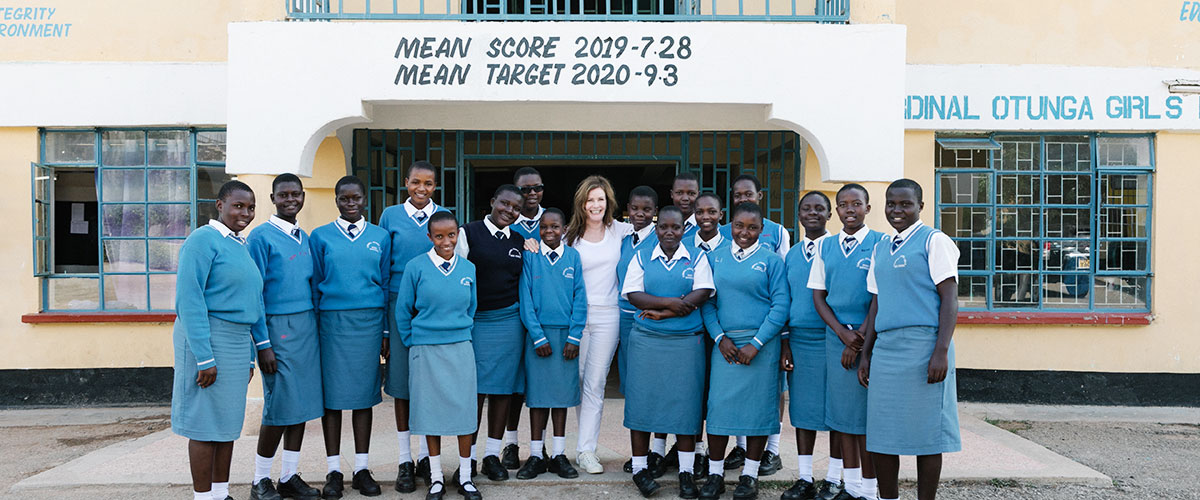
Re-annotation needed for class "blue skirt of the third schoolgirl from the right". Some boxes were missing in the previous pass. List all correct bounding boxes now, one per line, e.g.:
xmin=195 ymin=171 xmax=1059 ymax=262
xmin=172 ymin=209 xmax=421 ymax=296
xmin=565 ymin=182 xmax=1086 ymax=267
xmin=787 ymin=329 xmax=829 ymax=430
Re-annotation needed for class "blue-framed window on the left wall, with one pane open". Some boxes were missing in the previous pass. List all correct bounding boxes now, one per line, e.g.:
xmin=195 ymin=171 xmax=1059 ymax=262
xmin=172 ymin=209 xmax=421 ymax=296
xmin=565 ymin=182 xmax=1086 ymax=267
xmin=31 ymin=128 xmax=229 ymax=312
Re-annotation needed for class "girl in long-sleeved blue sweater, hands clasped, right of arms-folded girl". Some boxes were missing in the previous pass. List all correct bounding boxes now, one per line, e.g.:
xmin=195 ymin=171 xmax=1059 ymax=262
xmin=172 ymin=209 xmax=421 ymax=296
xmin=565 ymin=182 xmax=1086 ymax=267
xmin=700 ymin=203 xmax=790 ymax=500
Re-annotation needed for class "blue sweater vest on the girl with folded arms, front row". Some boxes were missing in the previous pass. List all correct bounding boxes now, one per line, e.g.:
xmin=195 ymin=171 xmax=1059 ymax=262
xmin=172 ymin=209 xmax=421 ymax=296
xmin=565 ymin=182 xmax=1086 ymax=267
xmin=634 ymin=243 xmax=704 ymax=335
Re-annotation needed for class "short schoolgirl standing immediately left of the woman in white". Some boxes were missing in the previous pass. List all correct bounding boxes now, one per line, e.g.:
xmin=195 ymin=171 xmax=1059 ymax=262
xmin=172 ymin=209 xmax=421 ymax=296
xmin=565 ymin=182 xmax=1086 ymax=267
xmin=517 ymin=209 xmax=588 ymax=480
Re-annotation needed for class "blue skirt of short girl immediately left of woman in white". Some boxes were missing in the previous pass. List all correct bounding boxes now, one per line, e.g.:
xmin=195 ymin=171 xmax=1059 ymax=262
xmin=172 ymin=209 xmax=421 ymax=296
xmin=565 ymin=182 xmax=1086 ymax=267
xmin=524 ymin=326 xmax=580 ymax=408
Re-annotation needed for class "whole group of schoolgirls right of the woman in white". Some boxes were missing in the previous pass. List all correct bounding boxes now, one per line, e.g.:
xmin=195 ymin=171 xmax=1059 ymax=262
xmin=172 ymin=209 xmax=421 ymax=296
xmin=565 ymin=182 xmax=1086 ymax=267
xmin=618 ymin=174 xmax=960 ymax=500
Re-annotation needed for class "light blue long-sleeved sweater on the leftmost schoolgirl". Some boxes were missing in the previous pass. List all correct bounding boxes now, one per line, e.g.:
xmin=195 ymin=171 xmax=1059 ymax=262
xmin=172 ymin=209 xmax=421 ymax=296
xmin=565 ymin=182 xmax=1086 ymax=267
xmin=175 ymin=225 xmax=271 ymax=369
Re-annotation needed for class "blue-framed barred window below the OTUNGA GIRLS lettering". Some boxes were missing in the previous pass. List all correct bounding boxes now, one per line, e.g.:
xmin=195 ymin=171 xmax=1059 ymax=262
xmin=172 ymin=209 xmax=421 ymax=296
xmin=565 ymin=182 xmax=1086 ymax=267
xmin=935 ymin=133 xmax=1154 ymax=312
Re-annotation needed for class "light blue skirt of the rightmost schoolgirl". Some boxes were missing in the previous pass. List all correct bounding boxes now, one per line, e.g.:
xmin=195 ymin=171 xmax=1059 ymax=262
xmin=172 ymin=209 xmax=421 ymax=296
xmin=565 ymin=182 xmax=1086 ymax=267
xmin=866 ymin=326 xmax=962 ymax=456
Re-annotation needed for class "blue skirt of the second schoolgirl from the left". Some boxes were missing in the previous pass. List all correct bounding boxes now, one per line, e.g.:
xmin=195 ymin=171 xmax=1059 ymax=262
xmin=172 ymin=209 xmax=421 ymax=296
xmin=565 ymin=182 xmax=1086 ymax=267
xmin=263 ymin=309 xmax=325 ymax=426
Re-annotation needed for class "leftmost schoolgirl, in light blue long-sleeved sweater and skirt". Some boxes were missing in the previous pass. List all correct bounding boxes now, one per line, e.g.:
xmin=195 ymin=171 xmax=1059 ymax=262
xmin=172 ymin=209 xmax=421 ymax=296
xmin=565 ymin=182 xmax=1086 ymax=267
xmin=170 ymin=181 xmax=275 ymax=500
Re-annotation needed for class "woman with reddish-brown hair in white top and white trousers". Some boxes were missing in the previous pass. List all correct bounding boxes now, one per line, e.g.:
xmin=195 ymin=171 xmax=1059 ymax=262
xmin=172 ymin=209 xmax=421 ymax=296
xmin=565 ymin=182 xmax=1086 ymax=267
xmin=566 ymin=175 xmax=634 ymax=474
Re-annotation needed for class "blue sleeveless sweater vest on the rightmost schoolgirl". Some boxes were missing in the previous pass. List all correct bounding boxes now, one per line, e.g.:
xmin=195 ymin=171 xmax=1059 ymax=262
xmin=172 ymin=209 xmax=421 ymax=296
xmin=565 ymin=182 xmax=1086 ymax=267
xmin=875 ymin=225 xmax=942 ymax=332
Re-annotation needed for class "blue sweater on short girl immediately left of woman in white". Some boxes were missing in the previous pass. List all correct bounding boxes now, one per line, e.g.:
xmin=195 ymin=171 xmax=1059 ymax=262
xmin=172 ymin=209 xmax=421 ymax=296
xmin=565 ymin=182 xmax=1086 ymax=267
xmin=521 ymin=245 xmax=588 ymax=348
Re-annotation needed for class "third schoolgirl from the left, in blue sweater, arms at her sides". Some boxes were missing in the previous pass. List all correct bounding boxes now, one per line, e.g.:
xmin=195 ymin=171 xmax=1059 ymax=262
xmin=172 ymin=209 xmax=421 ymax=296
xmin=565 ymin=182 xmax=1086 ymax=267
xmin=311 ymin=175 xmax=391 ymax=499
